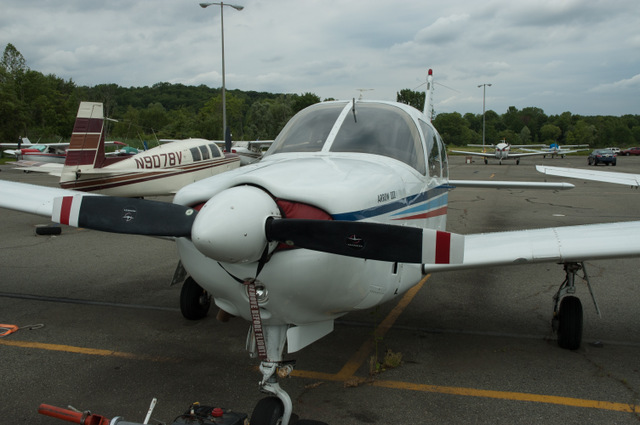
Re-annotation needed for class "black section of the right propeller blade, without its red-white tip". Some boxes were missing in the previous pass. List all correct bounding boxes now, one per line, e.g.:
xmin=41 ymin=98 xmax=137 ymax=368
xmin=266 ymin=219 xmax=423 ymax=263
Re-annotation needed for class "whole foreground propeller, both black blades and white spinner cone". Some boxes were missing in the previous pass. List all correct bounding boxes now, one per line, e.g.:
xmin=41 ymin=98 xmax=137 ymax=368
xmin=52 ymin=186 xmax=464 ymax=264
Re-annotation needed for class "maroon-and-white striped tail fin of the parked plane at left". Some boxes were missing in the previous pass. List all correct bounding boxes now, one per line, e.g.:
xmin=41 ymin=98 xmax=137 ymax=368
xmin=64 ymin=102 xmax=105 ymax=168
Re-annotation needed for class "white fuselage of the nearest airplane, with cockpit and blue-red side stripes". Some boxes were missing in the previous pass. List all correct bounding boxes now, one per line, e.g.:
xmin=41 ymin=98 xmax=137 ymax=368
xmin=174 ymin=101 xmax=449 ymax=325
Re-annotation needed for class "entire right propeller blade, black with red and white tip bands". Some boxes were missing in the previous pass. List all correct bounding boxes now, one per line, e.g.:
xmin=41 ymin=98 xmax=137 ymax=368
xmin=266 ymin=219 xmax=464 ymax=264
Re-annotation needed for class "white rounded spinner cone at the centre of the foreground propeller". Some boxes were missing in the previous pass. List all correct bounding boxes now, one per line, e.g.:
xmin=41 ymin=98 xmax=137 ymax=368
xmin=191 ymin=186 xmax=280 ymax=263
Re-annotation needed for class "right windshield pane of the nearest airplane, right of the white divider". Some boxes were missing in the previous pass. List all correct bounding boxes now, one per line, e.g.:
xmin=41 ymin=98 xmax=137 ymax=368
xmin=330 ymin=103 xmax=427 ymax=175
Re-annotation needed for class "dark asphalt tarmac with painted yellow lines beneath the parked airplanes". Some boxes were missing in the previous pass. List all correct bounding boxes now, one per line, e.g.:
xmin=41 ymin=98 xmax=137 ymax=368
xmin=0 ymin=156 xmax=640 ymax=425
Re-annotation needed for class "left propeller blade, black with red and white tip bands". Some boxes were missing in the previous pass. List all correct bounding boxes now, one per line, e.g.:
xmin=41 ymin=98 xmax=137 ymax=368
xmin=51 ymin=194 xmax=196 ymax=237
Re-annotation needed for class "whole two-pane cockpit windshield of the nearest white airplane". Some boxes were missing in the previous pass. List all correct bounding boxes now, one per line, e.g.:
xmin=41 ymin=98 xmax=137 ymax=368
xmin=265 ymin=102 xmax=427 ymax=175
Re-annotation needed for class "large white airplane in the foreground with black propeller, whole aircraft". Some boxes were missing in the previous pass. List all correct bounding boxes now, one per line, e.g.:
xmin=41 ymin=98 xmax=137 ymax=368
xmin=0 ymin=70 xmax=640 ymax=425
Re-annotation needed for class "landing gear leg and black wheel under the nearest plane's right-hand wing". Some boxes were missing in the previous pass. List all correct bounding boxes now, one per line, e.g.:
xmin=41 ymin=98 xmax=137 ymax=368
xmin=551 ymin=263 xmax=600 ymax=350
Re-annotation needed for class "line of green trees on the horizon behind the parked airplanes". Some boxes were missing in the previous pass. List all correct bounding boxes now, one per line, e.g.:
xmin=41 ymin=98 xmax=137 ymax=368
xmin=0 ymin=44 xmax=640 ymax=151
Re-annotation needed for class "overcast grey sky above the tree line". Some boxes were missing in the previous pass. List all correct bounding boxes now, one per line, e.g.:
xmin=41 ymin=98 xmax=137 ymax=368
xmin=0 ymin=0 xmax=640 ymax=115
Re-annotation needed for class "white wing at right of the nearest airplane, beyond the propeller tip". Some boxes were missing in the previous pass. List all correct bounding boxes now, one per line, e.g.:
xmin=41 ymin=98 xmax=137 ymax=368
xmin=423 ymin=221 xmax=640 ymax=273
